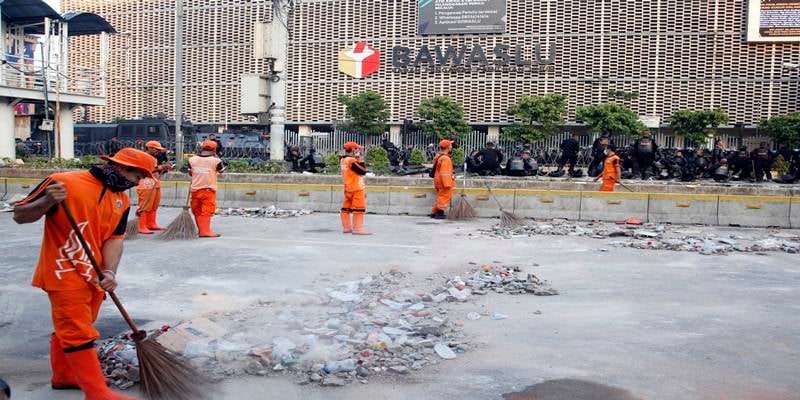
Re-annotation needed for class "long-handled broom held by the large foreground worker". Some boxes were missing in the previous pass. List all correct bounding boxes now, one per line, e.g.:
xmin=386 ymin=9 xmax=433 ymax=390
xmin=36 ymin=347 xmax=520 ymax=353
xmin=61 ymin=203 xmax=211 ymax=400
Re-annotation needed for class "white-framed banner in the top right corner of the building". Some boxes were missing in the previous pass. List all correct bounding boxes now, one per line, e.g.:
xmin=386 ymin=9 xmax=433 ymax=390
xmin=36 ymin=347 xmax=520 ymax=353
xmin=747 ymin=0 xmax=800 ymax=42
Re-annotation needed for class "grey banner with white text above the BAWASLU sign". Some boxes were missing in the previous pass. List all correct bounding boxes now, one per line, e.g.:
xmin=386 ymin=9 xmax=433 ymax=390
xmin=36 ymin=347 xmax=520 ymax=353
xmin=417 ymin=0 xmax=506 ymax=35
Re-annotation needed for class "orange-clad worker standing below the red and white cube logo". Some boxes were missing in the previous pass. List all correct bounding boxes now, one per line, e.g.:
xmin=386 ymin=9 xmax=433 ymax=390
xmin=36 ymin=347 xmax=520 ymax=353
xmin=339 ymin=142 xmax=372 ymax=235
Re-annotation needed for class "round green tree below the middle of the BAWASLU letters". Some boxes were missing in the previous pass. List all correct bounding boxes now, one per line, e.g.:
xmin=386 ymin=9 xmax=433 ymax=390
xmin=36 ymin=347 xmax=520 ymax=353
xmin=417 ymin=96 xmax=472 ymax=139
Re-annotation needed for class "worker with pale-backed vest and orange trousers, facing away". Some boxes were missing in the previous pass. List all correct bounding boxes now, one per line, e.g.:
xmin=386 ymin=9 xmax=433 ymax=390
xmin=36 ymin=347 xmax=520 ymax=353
xmin=189 ymin=140 xmax=225 ymax=238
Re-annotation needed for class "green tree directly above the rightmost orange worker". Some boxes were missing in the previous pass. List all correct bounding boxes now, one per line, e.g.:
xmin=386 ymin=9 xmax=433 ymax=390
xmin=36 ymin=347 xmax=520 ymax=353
xmin=575 ymin=103 xmax=645 ymax=137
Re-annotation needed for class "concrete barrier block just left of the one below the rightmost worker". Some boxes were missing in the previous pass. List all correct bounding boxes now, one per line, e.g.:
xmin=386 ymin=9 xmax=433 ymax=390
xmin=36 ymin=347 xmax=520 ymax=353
xmin=514 ymin=189 xmax=581 ymax=220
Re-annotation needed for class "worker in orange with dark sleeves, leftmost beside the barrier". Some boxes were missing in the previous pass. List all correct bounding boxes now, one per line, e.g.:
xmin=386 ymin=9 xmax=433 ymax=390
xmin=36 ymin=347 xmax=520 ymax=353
xmin=136 ymin=140 xmax=171 ymax=235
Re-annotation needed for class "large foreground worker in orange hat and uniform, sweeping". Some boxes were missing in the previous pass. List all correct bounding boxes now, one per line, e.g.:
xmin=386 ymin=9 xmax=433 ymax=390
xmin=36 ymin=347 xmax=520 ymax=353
xmin=14 ymin=148 xmax=156 ymax=400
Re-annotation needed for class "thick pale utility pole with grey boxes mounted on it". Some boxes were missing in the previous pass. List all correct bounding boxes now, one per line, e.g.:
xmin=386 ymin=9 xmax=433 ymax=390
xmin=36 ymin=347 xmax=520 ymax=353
xmin=269 ymin=0 xmax=293 ymax=161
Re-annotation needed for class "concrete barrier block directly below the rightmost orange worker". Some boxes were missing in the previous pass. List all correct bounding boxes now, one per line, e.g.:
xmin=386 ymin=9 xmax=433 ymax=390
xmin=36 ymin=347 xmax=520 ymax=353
xmin=580 ymin=192 xmax=649 ymax=221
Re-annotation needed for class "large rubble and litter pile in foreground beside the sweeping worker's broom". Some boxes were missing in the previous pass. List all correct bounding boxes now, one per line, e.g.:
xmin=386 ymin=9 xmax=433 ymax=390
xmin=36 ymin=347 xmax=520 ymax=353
xmin=112 ymin=265 xmax=558 ymax=387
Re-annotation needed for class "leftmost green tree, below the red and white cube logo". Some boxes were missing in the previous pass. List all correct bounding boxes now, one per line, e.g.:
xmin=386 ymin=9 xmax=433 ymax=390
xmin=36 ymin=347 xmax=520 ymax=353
xmin=337 ymin=90 xmax=390 ymax=136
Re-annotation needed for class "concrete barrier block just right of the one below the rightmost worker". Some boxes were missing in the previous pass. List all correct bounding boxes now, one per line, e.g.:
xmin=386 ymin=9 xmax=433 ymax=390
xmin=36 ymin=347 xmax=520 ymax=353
xmin=647 ymin=193 xmax=719 ymax=225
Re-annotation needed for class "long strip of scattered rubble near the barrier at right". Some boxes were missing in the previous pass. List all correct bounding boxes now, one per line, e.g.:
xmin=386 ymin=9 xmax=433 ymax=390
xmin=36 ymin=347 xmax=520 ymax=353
xmin=479 ymin=220 xmax=800 ymax=255
